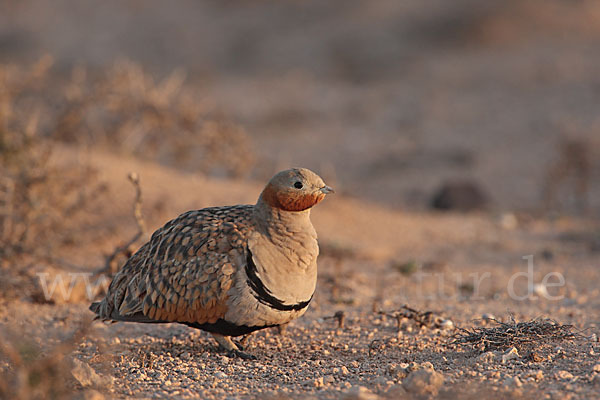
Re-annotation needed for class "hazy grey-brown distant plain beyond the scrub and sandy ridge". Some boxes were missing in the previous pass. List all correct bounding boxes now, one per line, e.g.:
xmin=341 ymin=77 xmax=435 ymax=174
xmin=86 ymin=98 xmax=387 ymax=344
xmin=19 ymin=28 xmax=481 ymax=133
xmin=0 ymin=0 xmax=600 ymax=210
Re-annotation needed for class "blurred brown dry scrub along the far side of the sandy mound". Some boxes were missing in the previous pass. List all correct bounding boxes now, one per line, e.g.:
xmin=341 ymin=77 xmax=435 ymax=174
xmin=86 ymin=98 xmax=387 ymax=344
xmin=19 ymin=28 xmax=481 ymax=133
xmin=0 ymin=57 xmax=254 ymax=176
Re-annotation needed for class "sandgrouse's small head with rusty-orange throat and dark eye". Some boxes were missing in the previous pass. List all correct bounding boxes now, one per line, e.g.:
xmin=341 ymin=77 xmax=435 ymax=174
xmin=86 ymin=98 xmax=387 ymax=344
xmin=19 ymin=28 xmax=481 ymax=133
xmin=261 ymin=168 xmax=334 ymax=211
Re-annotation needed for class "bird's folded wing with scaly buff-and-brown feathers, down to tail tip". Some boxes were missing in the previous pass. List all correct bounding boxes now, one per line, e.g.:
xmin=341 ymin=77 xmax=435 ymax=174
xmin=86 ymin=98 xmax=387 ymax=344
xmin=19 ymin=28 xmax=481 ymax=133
xmin=90 ymin=206 xmax=252 ymax=324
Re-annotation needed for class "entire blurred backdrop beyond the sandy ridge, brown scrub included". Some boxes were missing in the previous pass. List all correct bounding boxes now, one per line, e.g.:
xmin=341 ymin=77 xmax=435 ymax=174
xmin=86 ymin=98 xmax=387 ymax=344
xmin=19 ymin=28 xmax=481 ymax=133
xmin=0 ymin=0 xmax=600 ymax=214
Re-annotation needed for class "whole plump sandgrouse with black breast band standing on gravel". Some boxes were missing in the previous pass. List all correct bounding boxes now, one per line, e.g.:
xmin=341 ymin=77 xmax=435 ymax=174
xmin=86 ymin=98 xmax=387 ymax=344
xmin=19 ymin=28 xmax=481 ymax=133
xmin=90 ymin=168 xmax=333 ymax=357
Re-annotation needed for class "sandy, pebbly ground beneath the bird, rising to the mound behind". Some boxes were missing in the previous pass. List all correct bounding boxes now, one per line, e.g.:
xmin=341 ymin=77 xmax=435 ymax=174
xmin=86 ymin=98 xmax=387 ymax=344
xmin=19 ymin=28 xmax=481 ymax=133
xmin=0 ymin=148 xmax=600 ymax=398
